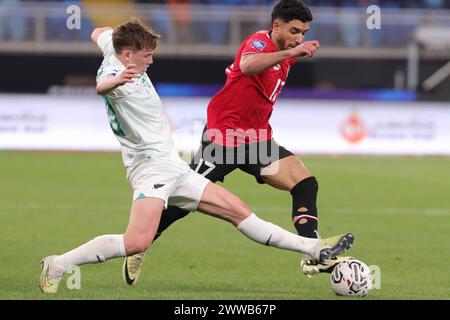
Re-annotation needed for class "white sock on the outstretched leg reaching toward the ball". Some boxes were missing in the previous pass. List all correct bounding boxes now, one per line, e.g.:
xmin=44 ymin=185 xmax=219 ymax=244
xmin=237 ymin=212 xmax=318 ymax=254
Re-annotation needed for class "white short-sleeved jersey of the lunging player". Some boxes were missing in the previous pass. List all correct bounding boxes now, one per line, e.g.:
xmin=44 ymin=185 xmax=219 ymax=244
xmin=97 ymin=30 xmax=182 ymax=167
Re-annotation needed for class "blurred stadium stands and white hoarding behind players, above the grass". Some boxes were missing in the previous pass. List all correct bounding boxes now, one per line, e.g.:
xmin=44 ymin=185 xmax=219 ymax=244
xmin=0 ymin=0 xmax=450 ymax=155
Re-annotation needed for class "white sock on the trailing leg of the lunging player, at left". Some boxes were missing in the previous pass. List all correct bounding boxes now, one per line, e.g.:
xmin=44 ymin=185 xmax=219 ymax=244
xmin=53 ymin=234 xmax=126 ymax=272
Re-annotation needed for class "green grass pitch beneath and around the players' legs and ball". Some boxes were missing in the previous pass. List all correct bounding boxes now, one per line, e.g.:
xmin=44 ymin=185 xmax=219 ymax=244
xmin=0 ymin=151 xmax=450 ymax=300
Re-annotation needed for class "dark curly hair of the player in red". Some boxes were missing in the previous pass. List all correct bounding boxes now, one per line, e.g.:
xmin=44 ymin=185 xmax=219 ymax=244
xmin=272 ymin=0 xmax=313 ymax=23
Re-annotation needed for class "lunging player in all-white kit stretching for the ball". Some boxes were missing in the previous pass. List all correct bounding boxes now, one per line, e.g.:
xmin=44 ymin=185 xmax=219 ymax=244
xmin=40 ymin=19 xmax=354 ymax=293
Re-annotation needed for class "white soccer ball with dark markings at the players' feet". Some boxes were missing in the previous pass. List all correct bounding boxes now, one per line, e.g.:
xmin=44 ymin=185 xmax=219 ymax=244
xmin=330 ymin=258 xmax=372 ymax=297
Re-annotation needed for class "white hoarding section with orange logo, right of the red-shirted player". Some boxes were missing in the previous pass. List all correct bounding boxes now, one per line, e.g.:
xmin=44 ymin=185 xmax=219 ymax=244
xmin=272 ymin=101 xmax=450 ymax=155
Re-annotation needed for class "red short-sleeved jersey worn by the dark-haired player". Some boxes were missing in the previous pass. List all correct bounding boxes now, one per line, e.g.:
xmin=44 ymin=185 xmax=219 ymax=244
xmin=207 ymin=32 xmax=297 ymax=146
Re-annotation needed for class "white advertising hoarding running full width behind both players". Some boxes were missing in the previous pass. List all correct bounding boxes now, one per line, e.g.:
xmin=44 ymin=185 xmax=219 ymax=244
xmin=0 ymin=94 xmax=450 ymax=156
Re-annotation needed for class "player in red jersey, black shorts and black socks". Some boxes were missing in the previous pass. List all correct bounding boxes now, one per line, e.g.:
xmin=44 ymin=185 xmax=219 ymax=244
xmin=123 ymin=0 xmax=348 ymax=284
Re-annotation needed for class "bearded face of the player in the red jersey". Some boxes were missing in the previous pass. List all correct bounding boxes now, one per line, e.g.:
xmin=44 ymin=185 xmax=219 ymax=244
xmin=272 ymin=19 xmax=309 ymax=50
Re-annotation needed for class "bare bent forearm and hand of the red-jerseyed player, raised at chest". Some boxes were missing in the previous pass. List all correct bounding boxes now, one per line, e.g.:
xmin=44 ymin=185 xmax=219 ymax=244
xmin=239 ymin=40 xmax=319 ymax=76
